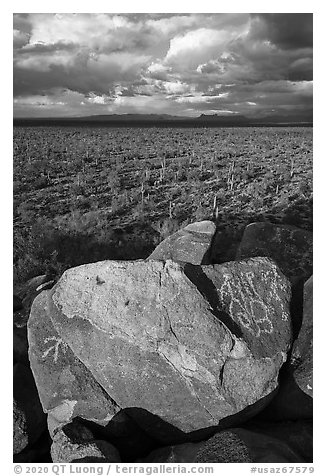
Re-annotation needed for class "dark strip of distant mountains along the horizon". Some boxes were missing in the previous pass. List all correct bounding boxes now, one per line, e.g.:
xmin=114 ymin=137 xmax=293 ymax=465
xmin=14 ymin=114 xmax=312 ymax=127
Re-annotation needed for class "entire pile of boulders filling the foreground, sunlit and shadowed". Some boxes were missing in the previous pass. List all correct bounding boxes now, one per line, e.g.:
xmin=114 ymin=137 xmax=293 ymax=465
xmin=18 ymin=221 xmax=312 ymax=463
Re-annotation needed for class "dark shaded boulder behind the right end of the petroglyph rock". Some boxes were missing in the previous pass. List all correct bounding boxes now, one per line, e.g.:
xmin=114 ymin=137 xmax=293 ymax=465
xmin=236 ymin=222 xmax=313 ymax=279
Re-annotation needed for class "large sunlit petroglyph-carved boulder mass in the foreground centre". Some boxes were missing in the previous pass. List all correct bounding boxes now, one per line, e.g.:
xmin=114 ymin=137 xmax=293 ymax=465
xmin=29 ymin=258 xmax=292 ymax=437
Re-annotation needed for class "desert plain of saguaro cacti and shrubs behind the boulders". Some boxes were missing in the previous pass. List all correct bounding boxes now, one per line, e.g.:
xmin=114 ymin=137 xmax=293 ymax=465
xmin=14 ymin=127 xmax=312 ymax=281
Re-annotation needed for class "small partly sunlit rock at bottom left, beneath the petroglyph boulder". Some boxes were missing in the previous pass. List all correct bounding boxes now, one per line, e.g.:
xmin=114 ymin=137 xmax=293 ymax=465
xmin=51 ymin=421 xmax=121 ymax=463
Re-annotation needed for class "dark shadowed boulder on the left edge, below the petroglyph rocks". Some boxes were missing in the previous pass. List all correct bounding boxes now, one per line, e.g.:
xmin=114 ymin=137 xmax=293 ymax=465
xmin=13 ymin=364 xmax=46 ymax=454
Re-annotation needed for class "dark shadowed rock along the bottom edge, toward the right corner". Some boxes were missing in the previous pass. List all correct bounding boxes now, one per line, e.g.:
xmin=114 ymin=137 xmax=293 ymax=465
xmin=138 ymin=423 xmax=312 ymax=463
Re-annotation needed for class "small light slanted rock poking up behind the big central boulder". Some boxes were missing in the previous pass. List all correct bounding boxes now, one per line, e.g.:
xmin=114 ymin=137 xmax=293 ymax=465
xmin=148 ymin=220 xmax=216 ymax=264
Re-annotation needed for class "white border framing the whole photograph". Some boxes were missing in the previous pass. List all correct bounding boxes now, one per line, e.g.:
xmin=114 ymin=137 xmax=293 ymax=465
xmin=0 ymin=0 xmax=326 ymax=475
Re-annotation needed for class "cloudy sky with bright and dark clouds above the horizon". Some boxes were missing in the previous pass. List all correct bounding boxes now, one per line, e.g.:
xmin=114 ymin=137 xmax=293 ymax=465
xmin=13 ymin=13 xmax=313 ymax=119
